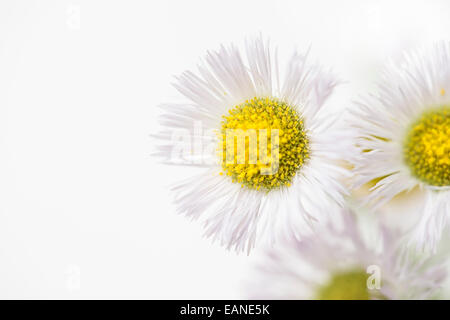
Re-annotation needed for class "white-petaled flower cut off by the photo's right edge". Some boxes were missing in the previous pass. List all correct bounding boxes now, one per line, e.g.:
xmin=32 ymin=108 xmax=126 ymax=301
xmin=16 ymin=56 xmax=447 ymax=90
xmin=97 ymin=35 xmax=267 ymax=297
xmin=353 ymin=43 xmax=450 ymax=250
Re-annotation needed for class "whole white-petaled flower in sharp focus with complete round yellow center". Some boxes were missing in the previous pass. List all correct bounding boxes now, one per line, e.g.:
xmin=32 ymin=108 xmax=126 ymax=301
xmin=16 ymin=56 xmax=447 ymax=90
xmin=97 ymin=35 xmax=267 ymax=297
xmin=156 ymin=38 xmax=347 ymax=251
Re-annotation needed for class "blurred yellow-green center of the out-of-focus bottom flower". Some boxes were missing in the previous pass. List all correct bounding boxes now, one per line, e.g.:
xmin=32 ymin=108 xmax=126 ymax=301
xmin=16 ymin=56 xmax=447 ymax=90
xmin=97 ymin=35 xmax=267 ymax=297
xmin=317 ymin=270 xmax=370 ymax=300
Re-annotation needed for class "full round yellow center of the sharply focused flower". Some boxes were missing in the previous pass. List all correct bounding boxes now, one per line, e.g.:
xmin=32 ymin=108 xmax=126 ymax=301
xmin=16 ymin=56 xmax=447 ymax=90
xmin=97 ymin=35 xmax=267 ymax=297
xmin=219 ymin=98 xmax=308 ymax=191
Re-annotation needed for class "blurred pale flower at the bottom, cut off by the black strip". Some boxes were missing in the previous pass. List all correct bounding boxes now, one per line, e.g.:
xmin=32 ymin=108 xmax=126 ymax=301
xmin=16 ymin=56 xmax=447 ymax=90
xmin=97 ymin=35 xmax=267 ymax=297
xmin=246 ymin=209 xmax=446 ymax=300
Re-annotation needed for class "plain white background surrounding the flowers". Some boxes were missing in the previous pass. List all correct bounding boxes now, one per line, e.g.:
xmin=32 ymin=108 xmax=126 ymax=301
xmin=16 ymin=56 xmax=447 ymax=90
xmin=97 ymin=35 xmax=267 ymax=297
xmin=0 ymin=0 xmax=450 ymax=299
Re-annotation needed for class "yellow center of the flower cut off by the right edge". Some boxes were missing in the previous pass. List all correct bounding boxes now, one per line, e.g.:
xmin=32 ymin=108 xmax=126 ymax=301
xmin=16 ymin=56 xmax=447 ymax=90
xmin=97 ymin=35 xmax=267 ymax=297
xmin=404 ymin=106 xmax=450 ymax=187
